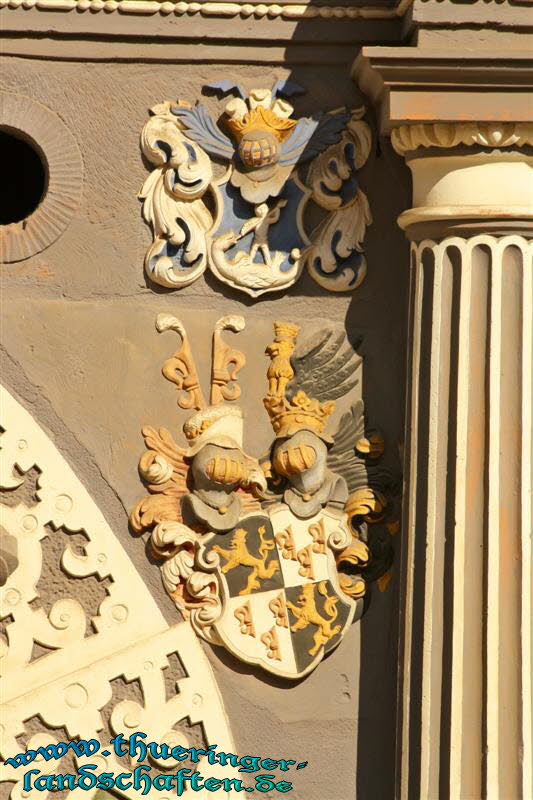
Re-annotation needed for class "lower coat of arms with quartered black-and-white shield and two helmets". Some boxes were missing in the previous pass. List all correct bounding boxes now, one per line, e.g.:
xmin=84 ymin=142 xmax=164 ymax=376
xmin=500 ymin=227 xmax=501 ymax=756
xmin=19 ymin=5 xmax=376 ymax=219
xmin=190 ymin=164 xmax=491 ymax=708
xmin=130 ymin=314 xmax=392 ymax=678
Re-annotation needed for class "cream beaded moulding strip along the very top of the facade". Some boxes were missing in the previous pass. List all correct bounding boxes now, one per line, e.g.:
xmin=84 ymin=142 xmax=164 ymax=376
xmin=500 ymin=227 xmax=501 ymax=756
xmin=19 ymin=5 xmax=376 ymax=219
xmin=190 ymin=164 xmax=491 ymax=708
xmin=0 ymin=0 xmax=413 ymax=20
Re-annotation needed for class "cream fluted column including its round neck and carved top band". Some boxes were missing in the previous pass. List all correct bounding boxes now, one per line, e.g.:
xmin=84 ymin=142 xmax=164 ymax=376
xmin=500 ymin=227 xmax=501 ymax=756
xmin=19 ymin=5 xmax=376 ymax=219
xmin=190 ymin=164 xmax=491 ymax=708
xmin=391 ymin=123 xmax=533 ymax=800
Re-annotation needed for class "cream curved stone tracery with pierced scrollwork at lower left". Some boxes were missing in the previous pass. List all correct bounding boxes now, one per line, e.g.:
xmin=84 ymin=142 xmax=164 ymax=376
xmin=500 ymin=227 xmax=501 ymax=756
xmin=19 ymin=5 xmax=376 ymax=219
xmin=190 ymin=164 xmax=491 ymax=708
xmin=0 ymin=388 xmax=234 ymax=800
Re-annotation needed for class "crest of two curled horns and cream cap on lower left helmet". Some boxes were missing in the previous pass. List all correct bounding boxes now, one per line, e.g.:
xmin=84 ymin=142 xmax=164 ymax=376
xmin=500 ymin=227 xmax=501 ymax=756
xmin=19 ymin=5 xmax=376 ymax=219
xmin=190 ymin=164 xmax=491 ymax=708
xmin=156 ymin=314 xmax=251 ymax=460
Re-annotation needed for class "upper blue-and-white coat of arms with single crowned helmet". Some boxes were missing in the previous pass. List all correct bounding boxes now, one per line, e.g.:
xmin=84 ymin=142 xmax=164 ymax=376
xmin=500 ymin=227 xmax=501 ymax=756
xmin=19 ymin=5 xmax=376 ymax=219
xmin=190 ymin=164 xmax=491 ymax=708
xmin=139 ymin=81 xmax=371 ymax=297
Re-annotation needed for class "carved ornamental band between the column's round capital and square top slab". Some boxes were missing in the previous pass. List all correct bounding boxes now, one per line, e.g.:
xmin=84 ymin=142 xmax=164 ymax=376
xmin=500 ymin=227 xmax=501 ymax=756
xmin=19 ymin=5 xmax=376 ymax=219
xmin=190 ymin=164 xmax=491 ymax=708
xmin=391 ymin=122 xmax=533 ymax=156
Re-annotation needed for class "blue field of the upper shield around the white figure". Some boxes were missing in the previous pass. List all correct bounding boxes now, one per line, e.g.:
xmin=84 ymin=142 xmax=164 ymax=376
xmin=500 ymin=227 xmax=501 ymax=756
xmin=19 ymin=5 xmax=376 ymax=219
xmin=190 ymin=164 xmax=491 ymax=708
xmin=213 ymin=180 xmax=306 ymax=272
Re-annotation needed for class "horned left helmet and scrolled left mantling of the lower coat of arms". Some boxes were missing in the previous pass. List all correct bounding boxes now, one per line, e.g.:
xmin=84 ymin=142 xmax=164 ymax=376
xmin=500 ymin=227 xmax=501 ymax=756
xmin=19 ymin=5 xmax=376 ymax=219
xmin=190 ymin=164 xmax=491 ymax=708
xmin=130 ymin=314 xmax=265 ymax=643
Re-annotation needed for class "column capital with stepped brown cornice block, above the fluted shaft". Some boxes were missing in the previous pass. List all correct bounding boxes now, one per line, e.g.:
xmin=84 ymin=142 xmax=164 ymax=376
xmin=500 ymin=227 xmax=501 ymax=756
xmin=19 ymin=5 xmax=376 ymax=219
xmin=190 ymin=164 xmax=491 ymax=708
xmin=353 ymin=43 xmax=533 ymax=241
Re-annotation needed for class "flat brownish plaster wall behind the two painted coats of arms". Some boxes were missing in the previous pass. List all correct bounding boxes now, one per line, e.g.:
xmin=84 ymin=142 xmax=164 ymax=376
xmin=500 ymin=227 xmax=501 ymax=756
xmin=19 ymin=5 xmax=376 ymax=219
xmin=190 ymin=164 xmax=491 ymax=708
xmin=0 ymin=51 xmax=410 ymax=800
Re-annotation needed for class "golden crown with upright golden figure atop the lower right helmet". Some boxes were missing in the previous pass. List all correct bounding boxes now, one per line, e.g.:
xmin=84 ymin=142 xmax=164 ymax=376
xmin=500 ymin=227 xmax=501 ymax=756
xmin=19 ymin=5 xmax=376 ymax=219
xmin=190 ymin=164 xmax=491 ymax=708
xmin=263 ymin=322 xmax=335 ymax=438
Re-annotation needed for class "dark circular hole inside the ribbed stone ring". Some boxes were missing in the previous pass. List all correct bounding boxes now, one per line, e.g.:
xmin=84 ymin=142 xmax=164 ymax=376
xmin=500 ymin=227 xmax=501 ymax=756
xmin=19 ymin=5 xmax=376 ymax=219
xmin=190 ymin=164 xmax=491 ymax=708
xmin=0 ymin=128 xmax=47 ymax=225
